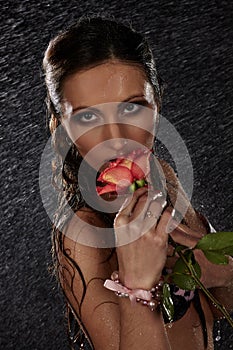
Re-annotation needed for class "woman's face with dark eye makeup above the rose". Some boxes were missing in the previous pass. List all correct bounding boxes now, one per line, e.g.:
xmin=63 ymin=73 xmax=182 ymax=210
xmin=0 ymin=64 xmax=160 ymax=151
xmin=62 ymin=61 xmax=157 ymax=170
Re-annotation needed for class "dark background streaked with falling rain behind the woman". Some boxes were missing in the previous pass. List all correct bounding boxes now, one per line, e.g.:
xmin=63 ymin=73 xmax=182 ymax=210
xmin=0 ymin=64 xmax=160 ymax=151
xmin=0 ymin=0 xmax=233 ymax=350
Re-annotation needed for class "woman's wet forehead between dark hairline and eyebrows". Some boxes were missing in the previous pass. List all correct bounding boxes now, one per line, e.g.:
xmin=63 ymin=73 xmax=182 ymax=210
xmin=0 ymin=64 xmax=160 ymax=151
xmin=63 ymin=61 xmax=148 ymax=107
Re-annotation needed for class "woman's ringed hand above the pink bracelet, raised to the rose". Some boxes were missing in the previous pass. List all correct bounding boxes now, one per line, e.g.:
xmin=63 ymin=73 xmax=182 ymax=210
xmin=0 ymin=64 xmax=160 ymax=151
xmin=114 ymin=188 xmax=172 ymax=289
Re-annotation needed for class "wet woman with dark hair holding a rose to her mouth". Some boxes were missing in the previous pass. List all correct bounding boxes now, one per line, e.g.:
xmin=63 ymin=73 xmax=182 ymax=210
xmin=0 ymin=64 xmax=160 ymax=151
xmin=44 ymin=16 xmax=232 ymax=350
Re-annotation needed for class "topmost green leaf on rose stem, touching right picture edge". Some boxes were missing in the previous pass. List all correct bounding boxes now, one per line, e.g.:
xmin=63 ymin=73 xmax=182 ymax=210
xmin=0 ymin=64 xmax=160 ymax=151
xmin=195 ymin=232 xmax=233 ymax=255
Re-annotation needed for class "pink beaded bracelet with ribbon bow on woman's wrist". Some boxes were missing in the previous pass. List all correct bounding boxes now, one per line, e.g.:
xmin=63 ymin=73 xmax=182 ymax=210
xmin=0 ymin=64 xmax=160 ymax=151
xmin=104 ymin=271 xmax=163 ymax=311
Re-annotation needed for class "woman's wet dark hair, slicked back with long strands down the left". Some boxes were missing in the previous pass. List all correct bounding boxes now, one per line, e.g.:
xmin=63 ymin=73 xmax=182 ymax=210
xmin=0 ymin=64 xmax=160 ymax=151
xmin=43 ymin=15 xmax=163 ymax=347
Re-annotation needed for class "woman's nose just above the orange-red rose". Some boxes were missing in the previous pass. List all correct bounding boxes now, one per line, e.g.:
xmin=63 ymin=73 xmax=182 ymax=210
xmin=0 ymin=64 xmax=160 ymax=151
xmin=106 ymin=123 xmax=127 ymax=153
